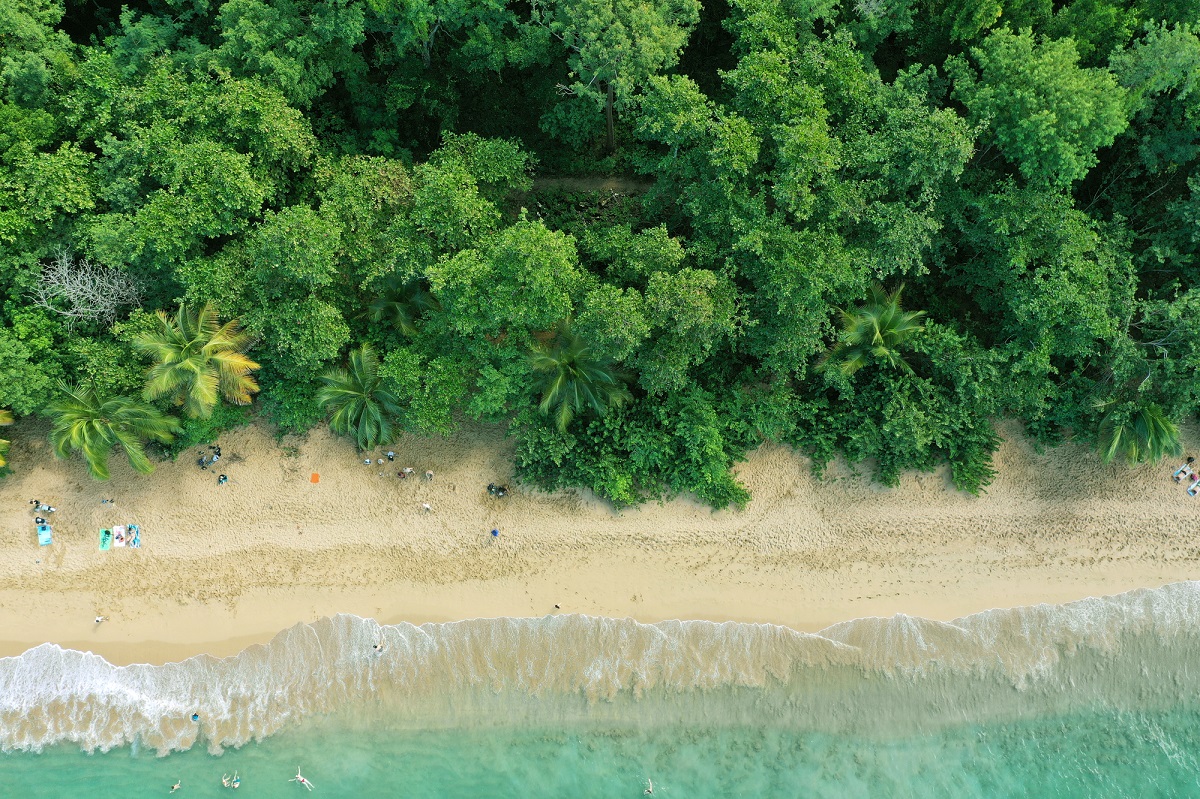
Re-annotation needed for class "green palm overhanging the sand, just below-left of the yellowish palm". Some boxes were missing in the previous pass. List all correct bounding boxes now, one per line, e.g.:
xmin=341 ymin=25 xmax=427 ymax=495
xmin=46 ymin=382 xmax=179 ymax=480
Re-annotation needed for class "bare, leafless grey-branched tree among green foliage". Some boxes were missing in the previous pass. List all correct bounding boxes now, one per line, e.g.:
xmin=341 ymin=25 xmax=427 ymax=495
xmin=31 ymin=250 xmax=142 ymax=329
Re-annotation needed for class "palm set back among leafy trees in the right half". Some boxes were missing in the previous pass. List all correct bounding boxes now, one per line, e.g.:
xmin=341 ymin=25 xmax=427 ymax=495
xmin=818 ymin=283 xmax=925 ymax=376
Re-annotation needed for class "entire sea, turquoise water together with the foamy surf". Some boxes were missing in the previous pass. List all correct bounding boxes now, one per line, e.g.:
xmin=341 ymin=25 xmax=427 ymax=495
xmin=0 ymin=583 xmax=1200 ymax=799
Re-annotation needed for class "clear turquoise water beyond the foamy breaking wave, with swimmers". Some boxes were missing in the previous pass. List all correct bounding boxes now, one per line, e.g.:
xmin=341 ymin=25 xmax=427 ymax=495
xmin=0 ymin=710 xmax=1200 ymax=799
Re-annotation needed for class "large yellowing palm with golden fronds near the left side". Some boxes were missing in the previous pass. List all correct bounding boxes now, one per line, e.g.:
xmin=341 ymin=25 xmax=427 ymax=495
xmin=133 ymin=304 xmax=258 ymax=419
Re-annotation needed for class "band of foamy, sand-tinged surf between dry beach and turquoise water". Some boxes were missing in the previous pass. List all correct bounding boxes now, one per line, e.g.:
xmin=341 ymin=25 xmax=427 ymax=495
xmin=0 ymin=582 xmax=1200 ymax=753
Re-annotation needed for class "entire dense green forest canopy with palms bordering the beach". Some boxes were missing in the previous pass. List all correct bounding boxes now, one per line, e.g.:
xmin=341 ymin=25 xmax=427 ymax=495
xmin=0 ymin=0 xmax=1200 ymax=506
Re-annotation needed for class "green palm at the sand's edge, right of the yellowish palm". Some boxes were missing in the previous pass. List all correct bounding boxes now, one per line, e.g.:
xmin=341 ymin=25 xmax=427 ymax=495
xmin=317 ymin=344 xmax=401 ymax=450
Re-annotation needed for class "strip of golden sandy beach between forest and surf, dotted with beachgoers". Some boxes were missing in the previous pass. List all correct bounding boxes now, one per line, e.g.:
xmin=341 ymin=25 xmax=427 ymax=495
xmin=0 ymin=422 xmax=1200 ymax=663
